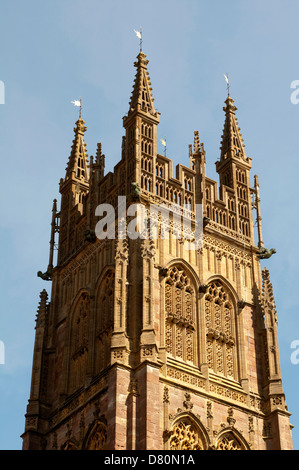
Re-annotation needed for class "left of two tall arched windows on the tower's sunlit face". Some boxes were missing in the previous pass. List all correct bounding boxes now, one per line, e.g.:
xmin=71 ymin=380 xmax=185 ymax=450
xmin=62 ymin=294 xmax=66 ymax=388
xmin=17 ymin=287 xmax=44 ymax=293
xmin=165 ymin=266 xmax=197 ymax=363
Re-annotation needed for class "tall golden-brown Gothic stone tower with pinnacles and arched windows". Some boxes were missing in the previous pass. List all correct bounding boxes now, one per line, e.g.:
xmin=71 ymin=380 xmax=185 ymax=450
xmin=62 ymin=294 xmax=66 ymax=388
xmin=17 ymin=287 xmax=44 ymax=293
xmin=22 ymin=51 xmax=292 ymax=450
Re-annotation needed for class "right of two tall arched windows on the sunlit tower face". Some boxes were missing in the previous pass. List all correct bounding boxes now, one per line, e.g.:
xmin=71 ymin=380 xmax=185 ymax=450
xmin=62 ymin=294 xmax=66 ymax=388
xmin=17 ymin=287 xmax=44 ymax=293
xmin=205 ymin=281 xmax=237 ymax=379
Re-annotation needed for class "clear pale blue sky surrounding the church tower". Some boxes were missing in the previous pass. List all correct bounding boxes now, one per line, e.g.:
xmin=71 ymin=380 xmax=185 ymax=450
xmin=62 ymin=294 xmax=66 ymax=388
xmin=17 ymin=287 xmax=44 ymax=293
xmin=0 ymin=0 xmax=299 ymax=449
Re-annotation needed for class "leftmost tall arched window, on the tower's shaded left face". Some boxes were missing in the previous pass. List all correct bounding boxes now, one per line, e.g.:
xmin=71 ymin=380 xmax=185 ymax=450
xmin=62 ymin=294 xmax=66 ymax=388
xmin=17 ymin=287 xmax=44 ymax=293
xmin=69 ymin=292 xmax=90 ymax=392
